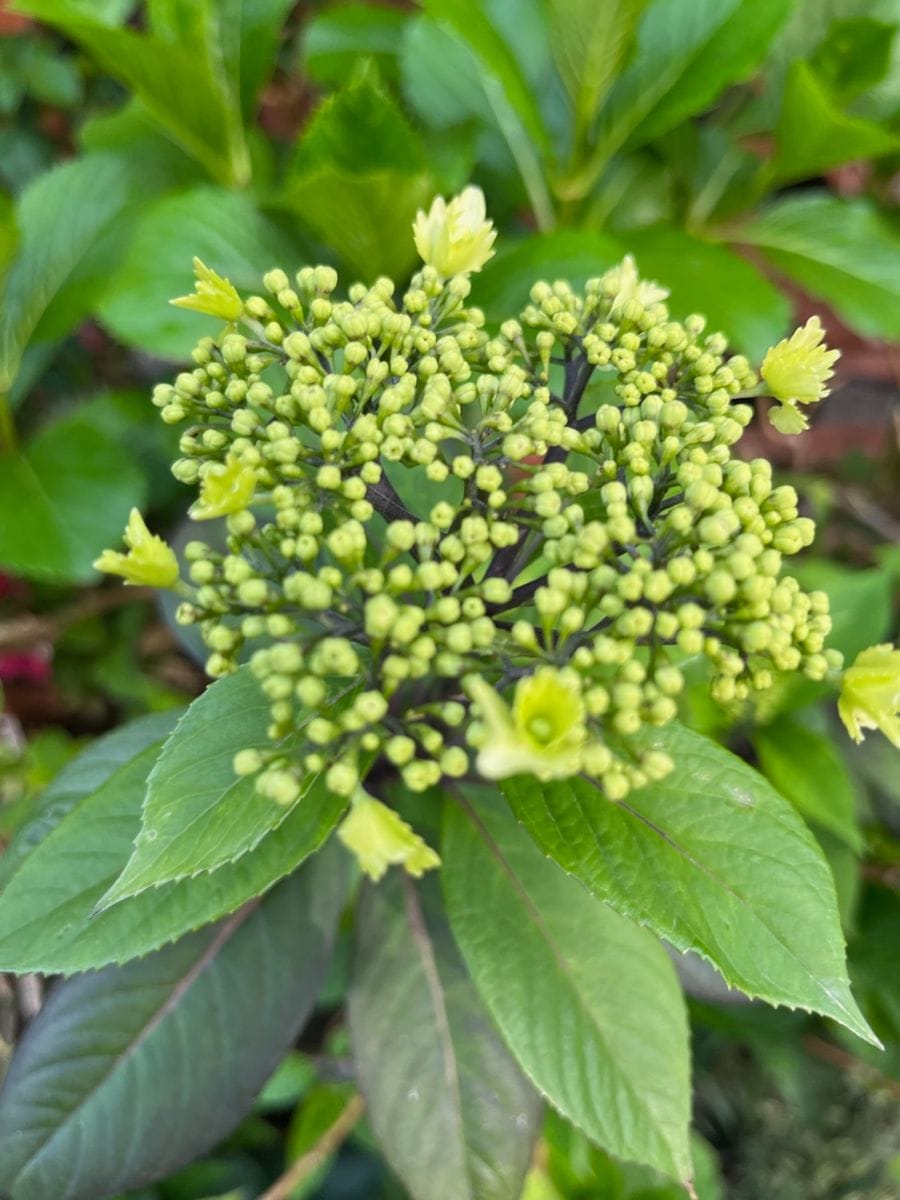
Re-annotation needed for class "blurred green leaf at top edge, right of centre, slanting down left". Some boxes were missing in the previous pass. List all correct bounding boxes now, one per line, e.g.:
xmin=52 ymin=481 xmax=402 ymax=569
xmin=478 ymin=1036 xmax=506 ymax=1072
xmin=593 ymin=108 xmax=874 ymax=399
xmin=581 ymin=0 xmax=790 ymax=186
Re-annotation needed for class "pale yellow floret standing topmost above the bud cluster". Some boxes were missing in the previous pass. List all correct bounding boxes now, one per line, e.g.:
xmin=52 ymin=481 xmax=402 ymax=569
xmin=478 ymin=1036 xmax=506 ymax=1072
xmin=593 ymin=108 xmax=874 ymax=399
xmin=413 ymin=187 xmax=497 ymax=278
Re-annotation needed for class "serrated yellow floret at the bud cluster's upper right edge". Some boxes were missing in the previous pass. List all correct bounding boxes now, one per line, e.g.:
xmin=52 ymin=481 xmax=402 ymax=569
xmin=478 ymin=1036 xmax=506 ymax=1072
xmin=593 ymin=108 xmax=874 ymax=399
xmin=760 ymin=317 xmax=840 ymax=433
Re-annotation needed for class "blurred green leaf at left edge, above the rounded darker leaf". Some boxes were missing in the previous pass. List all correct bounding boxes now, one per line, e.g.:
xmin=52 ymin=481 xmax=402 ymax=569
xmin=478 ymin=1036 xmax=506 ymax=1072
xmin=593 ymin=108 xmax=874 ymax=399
xmin=0 ymin=155 xmax=133 ymax=392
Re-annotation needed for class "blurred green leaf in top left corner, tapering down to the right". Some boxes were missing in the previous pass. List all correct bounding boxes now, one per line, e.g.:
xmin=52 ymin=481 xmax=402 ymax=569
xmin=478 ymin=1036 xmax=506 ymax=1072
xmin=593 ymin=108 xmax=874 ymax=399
xmin=12 ymin=0 xmax=250 ymax=184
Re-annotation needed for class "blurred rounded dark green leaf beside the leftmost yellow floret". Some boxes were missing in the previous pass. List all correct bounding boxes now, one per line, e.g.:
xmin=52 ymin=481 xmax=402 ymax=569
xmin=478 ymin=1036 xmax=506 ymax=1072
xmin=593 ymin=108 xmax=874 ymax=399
xmin=0 ymin=413 xmax=144 ymax=583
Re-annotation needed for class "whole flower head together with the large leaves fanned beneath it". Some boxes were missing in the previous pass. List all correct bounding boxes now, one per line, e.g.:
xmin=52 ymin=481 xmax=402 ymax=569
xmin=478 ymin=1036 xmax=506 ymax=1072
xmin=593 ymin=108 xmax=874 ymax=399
xmin=0 ymin=188 xmax=898 ymax=1200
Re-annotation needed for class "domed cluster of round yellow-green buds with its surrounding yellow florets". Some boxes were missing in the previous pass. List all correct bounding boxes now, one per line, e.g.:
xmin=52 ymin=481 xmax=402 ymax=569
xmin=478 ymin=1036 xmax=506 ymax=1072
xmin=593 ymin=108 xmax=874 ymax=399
xmin=97 ymin=188 xmax=894 ymax=877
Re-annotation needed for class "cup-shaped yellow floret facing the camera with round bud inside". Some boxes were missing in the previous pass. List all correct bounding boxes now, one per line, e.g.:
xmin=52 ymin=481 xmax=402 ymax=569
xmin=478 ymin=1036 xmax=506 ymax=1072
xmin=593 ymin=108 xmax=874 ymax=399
xmin=466 ymin=667 xmax=587 ymax=779
